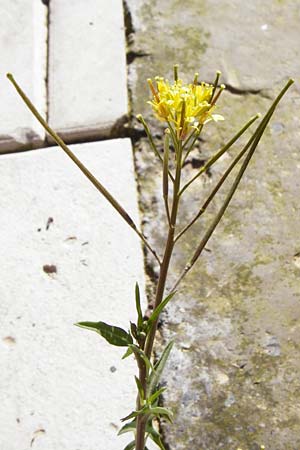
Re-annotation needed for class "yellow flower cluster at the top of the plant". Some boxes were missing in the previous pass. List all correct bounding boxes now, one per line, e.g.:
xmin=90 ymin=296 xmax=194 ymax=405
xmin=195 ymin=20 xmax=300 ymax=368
xmin=147 ymin=74 xmax=225 ymax=140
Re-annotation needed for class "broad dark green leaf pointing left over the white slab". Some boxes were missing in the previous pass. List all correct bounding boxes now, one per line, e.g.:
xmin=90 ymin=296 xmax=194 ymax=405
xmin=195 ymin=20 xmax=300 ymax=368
xmin=75 ymin=322 xmax=133 ymax=347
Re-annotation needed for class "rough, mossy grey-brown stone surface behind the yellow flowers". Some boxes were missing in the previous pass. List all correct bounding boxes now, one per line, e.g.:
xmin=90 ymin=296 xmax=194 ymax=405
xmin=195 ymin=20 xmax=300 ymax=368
xmin=127 ymin=0 xmax=300 ymax=450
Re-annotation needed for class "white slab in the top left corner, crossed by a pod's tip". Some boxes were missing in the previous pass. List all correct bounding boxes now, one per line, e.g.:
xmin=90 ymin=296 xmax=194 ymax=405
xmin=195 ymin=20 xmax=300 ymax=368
xmin=0 ymin=0 xmax=47 ymax=152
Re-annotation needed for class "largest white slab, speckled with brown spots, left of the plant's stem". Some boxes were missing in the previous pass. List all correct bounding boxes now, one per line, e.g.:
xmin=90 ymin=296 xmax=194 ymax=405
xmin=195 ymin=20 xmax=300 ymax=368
xmin=0 ymin=139 xmax=144 ymax=450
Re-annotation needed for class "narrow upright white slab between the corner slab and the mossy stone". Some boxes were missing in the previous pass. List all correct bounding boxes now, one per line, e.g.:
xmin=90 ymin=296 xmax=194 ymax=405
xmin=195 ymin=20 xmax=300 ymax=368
xmin=49 ymin=0 xmax=127 ymax=140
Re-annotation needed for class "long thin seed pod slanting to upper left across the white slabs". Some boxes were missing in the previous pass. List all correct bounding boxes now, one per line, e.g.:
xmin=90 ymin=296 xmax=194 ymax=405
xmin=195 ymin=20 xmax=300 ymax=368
xmin=7 ymin=73 xmax=161 ymax=264
